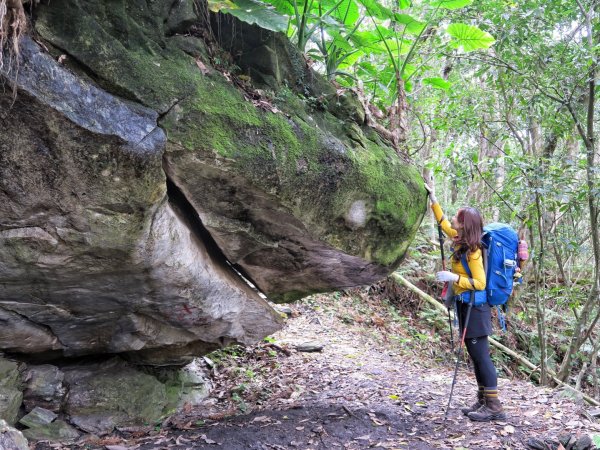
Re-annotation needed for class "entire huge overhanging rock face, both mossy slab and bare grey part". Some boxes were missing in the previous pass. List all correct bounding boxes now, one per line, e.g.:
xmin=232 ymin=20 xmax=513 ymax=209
xmin=0 ymin=0 xmax=426 ymax=366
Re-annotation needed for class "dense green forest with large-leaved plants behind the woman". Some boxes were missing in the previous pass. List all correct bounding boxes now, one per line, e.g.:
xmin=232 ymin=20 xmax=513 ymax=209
xmin=209 ymin=0 xmax=600 ymax=399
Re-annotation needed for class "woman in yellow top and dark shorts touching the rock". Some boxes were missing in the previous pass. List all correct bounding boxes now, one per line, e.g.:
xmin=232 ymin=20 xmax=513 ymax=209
xmin=425 ymin=185 xmax=506 ymax=422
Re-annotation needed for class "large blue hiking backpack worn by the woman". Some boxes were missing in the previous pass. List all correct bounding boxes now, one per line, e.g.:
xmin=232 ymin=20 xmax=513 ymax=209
xmin=461 ymin=222 xmax=519 ymax=330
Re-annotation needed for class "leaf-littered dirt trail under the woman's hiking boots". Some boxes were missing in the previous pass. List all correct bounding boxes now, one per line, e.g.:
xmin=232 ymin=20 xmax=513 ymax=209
xmin=36 ymin=296 xmax=600 ymax=450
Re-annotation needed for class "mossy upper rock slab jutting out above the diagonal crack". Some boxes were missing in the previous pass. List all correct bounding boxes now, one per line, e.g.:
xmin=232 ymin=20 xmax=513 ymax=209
xmin=36 ymin=0 xmax=426 ymax=300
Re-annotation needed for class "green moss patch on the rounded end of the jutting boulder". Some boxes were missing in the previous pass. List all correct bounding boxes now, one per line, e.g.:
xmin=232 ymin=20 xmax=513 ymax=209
xmin=161 ymin=80 xmax=425 ymax=266
